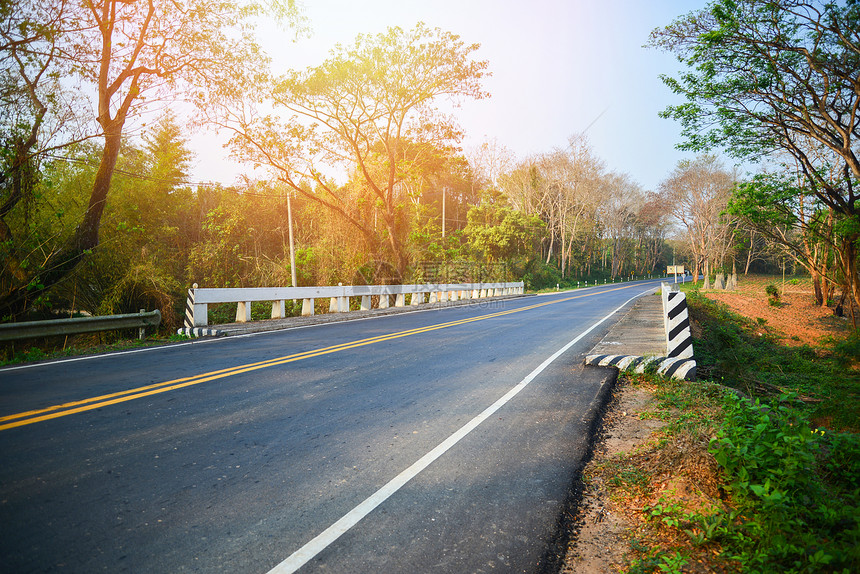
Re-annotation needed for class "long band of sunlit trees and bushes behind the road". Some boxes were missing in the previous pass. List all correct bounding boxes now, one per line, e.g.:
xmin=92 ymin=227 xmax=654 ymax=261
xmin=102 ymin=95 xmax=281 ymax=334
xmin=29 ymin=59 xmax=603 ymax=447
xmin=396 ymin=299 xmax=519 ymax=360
xmin=0 ymin=0 xmax=860 ymax=364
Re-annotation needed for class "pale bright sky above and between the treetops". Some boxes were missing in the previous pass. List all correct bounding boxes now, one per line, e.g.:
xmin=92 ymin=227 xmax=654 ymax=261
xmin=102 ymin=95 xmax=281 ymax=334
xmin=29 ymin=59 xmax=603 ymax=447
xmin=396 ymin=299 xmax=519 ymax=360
xmin=191 ymin=0 xmax=706 ymax=194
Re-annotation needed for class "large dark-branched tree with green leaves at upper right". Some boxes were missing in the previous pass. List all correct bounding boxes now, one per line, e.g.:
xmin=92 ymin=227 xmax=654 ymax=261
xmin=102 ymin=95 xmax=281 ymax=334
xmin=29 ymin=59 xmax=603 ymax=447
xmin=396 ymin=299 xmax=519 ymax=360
xmin=650 ymin=0 xmax=860 ymax=310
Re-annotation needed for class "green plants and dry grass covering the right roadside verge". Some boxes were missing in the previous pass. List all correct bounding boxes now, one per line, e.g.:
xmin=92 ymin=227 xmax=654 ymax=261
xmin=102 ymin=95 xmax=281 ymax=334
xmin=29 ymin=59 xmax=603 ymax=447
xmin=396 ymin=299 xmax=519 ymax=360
xmin=584 ymin=278 xmax=860 ymax=574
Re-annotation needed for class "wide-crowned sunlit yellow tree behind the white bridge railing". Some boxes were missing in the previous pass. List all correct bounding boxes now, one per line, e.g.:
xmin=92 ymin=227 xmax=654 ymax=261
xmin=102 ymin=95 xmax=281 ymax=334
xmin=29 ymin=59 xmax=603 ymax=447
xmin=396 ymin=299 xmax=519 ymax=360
xmin=222 ymin=24 xmax=487 ymax=284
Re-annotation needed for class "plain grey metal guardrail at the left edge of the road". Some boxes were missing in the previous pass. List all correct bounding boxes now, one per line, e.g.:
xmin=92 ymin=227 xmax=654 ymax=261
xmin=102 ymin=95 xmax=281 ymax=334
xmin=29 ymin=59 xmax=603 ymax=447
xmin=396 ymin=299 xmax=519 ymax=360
xmin=0 ymin=309 xmax=161 ymax=341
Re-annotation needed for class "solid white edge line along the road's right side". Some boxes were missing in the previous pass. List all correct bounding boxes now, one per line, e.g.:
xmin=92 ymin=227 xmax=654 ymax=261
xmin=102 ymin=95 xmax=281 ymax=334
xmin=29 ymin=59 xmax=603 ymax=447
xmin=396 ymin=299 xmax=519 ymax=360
xmin=268 ymin=289 xmax=651 ymax=574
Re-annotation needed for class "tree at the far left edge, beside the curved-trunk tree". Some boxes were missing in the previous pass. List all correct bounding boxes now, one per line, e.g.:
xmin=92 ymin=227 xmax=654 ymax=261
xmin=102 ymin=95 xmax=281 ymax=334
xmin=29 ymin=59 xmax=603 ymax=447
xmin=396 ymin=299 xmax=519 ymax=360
xmin=0 ymin=0 xmax=88 ymax=300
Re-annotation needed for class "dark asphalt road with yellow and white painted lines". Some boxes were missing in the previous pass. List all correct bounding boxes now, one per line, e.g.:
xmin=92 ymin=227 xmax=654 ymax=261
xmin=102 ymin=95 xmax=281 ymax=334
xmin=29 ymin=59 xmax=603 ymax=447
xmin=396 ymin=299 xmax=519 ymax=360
xmin=0 ymin=281 xmax=659 ymax=574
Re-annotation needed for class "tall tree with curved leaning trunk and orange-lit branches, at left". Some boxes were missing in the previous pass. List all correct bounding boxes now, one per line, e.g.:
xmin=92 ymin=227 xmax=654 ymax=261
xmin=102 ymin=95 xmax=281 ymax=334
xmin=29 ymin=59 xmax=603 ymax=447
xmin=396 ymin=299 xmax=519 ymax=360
xmin=0 ymin=0 xmax=294 ymax=317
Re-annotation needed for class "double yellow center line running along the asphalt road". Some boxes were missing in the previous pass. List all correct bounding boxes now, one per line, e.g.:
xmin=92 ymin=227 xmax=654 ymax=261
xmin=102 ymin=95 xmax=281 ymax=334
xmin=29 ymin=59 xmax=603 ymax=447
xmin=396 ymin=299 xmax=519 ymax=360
xmin=0 ymin=285 xmax=644 ymax=431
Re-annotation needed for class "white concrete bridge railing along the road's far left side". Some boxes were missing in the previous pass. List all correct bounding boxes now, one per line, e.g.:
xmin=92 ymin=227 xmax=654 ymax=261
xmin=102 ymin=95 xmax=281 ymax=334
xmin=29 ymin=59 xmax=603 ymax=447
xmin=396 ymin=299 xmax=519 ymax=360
xmin=185 ymin=281 xmax=524 ymax=328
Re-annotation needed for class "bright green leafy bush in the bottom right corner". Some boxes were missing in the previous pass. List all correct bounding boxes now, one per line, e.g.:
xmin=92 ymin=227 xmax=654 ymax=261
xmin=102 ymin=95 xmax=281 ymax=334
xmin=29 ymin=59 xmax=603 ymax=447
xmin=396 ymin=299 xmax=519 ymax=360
xmin=711 ymin=397 xmax=860 ymax=572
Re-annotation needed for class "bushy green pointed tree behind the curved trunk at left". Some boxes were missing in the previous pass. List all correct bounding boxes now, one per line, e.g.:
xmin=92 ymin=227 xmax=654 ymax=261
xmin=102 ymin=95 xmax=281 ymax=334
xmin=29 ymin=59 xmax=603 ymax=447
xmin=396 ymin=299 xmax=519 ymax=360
xmin=37 ymin=115 xmax=196 ymax=327
